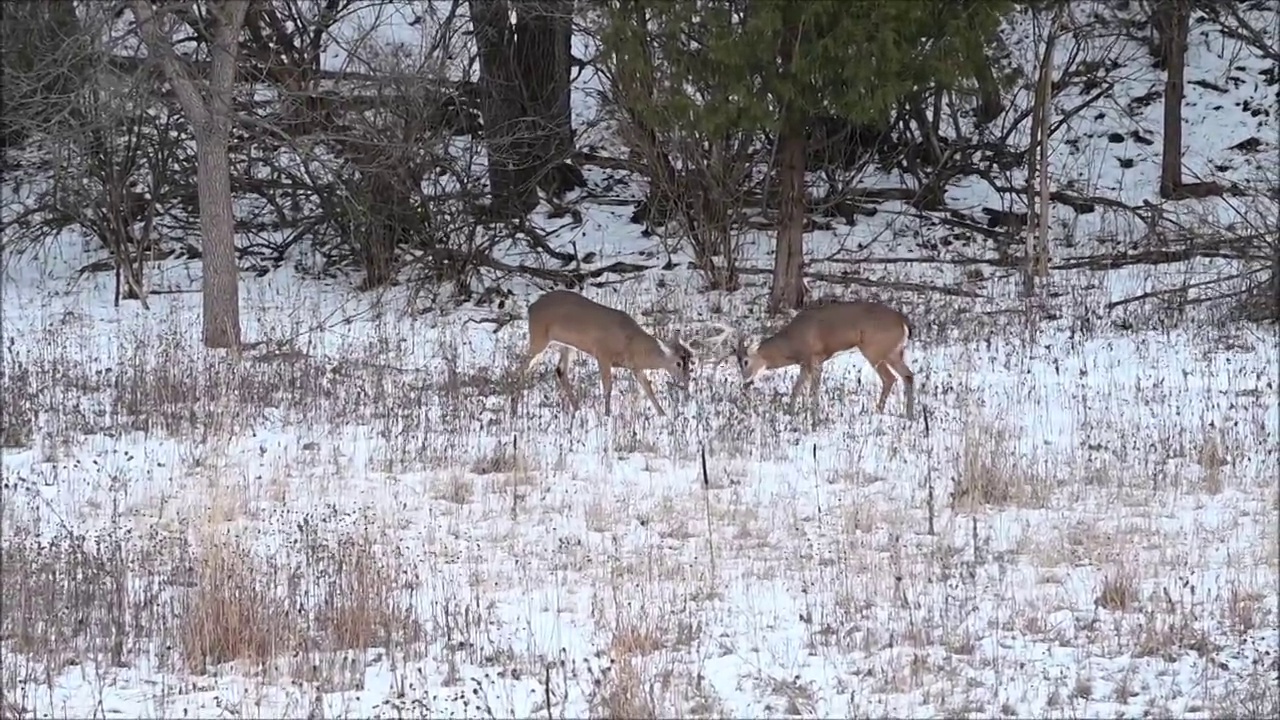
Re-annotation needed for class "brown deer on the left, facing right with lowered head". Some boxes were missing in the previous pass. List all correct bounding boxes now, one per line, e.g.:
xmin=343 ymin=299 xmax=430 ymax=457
xmin=525 ymin=290 xmax=694 ymax=416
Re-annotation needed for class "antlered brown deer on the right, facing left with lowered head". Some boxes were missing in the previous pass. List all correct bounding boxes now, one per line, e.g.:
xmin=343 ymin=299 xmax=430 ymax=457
xmin=716 ymin=300 xmax=915 ymax=419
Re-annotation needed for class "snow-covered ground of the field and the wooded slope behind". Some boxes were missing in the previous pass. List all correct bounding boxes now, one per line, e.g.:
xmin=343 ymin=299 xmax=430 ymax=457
xmin=0 ymin=1 xmax=1280 ymax=717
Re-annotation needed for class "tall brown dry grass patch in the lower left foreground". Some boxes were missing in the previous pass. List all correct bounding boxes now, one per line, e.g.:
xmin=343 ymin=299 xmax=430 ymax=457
xmin=0 ymin=502 xmax=426 ymax=691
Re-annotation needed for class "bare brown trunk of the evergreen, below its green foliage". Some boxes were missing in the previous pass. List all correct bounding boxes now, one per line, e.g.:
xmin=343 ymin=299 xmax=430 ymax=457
xmin=769 ymin=110 xmax=806 ymax=314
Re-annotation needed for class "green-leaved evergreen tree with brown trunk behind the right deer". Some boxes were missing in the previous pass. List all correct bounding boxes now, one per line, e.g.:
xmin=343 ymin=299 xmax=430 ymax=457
xmin=603 ymin=0 xmax=1010 ymax=311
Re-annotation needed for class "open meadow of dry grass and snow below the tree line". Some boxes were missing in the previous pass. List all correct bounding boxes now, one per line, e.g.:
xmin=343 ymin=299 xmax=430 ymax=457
xmin=0 ymin=279 xmax=1277 ymax=717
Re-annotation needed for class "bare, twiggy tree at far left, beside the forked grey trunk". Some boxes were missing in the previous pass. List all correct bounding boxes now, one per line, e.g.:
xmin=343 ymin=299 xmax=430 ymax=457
xmin=3 ymin=1 xmax=195 ymax=299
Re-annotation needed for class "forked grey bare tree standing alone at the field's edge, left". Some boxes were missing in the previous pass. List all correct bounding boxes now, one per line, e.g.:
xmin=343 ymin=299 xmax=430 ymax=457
xmin=132 ymin=0 xmax=250 ymax=347
